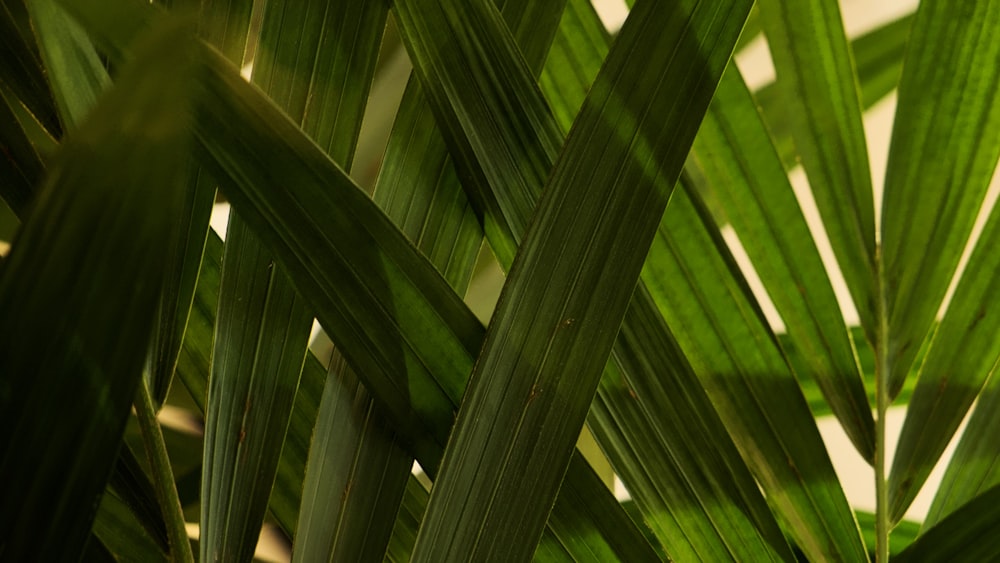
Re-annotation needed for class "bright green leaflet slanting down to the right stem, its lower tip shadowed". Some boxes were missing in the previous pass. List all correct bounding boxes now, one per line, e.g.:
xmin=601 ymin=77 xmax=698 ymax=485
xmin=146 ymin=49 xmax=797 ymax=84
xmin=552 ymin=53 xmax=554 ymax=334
xmin=689 ymin=66 xmax=875 ymax=463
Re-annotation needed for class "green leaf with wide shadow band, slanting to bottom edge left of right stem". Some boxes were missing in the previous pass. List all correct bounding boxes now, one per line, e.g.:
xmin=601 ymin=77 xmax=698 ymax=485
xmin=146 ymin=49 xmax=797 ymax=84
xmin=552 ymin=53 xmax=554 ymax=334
xmin=643 ymin=184 xmax=865 ymax=560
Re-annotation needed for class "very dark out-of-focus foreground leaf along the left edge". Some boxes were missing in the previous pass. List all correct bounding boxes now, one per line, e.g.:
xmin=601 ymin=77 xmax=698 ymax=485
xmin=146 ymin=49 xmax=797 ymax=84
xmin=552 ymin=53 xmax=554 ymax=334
xmin=0 ymin=17 xmax=201 ymax=559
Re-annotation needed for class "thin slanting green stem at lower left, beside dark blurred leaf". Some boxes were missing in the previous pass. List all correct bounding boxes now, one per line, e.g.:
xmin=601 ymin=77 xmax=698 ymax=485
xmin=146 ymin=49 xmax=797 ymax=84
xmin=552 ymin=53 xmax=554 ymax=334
xmin=135 ymin=377 xmax=194 ymax=563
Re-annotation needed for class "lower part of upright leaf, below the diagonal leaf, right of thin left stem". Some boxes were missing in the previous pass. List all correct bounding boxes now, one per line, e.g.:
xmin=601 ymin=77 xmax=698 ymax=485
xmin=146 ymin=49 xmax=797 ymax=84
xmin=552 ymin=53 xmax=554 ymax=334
xmin=200 ymin=214 xmax=311 ymax=560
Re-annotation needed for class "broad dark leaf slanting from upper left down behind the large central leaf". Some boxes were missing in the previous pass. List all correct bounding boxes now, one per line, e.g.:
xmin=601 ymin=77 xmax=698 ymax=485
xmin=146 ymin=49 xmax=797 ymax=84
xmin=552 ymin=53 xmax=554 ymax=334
xmin=67 ymin=4 xmax=648 ymax=552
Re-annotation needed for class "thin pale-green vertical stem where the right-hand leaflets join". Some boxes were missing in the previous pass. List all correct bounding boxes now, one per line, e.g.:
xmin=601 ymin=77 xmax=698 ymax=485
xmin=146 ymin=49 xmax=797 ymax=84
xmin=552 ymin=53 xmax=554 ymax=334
xmin=875 ymin=251 xmax=892 ymax=563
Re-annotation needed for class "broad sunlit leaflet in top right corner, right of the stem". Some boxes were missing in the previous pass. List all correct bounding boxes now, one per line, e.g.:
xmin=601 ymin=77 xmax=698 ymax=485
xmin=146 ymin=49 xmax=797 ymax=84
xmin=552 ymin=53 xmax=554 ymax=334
xmin=882 ymin=0 xmax=1000 ymax=396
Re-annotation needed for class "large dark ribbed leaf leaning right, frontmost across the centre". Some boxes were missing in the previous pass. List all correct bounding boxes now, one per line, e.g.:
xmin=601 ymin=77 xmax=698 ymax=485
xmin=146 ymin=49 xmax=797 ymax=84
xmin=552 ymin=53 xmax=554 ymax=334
xmin=397 ymin=0 xmax=748 ymax=559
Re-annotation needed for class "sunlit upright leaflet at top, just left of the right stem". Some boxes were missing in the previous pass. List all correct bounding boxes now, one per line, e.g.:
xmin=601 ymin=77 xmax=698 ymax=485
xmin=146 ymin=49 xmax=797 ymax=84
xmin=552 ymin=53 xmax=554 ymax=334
xmin=760 ymin=0 xmax=877 ymax=342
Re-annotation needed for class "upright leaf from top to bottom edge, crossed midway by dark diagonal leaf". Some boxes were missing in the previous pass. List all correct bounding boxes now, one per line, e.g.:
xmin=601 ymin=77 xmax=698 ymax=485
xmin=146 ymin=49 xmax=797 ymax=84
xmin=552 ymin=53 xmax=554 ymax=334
xmin=202 ymin=2 xmax=386 ymax=558
